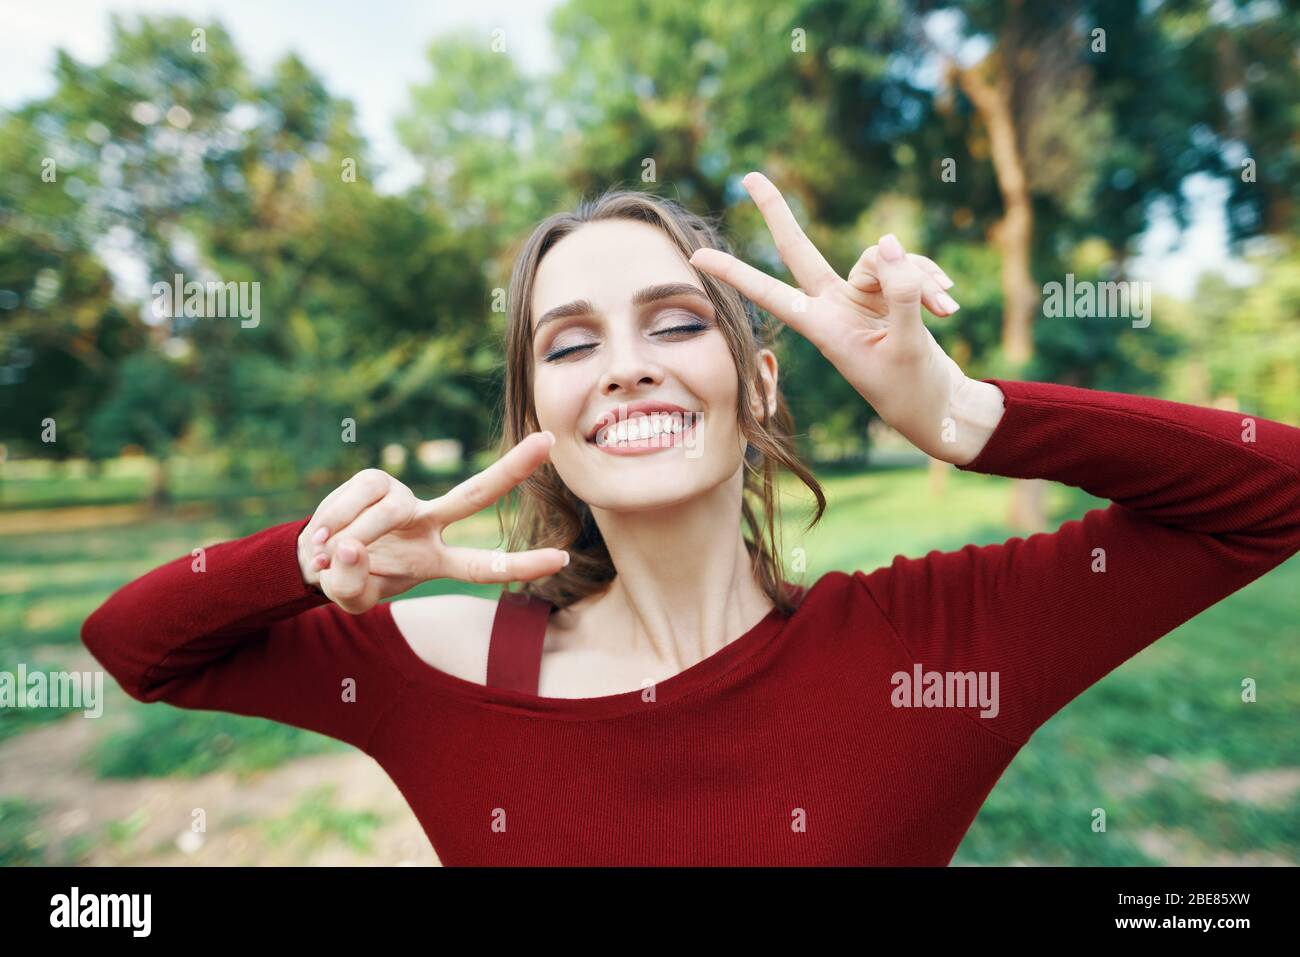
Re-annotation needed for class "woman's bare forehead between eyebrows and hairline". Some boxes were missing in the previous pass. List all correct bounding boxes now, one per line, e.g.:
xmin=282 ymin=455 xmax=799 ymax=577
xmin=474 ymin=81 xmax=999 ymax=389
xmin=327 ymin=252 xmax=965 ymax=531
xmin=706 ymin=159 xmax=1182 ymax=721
xmin=532 ymin=220 xmax=699 ymax=321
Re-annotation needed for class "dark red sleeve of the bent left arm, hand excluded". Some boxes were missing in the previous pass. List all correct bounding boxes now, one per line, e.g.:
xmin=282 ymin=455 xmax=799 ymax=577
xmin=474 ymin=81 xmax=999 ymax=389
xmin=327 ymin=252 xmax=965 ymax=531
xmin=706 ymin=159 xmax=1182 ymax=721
xmin=82 ymin=520 xmax=406 ymax=750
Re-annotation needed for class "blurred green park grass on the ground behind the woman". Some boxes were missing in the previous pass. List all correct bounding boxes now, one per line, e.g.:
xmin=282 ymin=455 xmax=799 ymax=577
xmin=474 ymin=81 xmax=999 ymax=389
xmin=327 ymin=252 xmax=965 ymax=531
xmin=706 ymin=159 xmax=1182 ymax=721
xmin=0 ymin=468 xmax=1300 ymax=865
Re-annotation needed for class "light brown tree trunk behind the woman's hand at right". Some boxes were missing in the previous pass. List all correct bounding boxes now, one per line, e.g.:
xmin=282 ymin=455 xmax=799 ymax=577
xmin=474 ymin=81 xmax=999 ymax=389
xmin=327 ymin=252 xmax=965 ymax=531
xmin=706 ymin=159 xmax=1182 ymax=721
xmin=956 ymin=51 xmax=1047 ymax=532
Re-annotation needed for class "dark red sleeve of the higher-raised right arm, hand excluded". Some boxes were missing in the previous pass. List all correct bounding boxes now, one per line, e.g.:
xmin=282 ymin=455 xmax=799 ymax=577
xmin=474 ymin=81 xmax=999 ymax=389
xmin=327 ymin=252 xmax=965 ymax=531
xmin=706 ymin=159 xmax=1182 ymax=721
xmin=853 ymin=380 xmax=1300 ymax=744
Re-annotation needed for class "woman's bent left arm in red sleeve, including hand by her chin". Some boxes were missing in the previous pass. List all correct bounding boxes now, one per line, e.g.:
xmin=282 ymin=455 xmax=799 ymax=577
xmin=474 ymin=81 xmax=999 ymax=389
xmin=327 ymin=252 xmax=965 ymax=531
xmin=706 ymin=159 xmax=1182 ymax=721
xmin=82 ymin=442 xmax=568 ymax=750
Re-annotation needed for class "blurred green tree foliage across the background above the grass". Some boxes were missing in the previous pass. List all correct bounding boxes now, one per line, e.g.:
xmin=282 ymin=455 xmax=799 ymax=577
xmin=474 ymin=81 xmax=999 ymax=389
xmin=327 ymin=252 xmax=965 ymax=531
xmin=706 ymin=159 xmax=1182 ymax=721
xmin=0 ymin=0 xmax=1300 ymax=492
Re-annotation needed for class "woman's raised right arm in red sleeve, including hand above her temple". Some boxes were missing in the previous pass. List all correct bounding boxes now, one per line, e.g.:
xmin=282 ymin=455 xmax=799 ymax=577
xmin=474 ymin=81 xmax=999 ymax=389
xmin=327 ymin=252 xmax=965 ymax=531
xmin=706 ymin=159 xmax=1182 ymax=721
xmin=690 ymin=173 xmax=1300 ymax=744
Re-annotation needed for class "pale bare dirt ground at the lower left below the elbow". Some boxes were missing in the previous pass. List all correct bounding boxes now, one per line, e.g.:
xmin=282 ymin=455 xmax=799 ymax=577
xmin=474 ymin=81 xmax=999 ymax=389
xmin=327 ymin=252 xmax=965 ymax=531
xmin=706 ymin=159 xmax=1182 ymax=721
xmin=0 ymin=650 xmax=438 ymax=866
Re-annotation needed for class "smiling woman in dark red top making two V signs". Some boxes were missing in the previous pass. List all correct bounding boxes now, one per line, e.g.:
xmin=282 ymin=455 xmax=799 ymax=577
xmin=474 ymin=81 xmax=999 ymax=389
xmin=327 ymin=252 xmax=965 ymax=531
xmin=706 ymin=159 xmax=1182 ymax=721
xmin=82 ymin=173 xmax=1300 ymax=865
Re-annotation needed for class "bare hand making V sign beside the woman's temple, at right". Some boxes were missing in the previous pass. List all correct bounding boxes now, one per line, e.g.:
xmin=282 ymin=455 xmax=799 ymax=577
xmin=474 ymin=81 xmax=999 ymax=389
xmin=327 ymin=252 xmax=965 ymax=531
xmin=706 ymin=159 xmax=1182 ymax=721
xmin=690 ymin=173 xmax=1002 ymax=464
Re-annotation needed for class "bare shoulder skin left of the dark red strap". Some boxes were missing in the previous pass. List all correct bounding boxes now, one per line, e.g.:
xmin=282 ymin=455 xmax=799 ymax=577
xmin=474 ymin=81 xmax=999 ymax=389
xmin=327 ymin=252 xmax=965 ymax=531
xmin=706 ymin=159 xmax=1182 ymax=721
xmin=390 ymin=594 xmax=497 ymax=684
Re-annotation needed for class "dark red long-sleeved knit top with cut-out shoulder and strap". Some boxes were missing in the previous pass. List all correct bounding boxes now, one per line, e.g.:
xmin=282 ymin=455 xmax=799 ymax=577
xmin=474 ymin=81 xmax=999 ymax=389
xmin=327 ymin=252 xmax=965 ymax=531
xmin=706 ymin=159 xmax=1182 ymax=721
xmin=82 ymin=380 xmax=1300 ymax=865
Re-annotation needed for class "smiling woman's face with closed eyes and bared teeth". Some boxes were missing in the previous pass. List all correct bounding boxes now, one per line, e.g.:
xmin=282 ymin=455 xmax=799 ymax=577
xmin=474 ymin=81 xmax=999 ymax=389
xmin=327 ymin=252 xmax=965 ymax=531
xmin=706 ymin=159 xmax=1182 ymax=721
xmin=532 ymin=220 xmax=776 ymax=511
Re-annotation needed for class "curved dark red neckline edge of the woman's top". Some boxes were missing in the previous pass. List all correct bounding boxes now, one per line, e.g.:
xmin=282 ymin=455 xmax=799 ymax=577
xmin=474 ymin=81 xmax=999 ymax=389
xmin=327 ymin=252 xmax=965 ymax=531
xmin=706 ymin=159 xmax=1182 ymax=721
xmin=374 ymin=586 xmax=806 ymax=720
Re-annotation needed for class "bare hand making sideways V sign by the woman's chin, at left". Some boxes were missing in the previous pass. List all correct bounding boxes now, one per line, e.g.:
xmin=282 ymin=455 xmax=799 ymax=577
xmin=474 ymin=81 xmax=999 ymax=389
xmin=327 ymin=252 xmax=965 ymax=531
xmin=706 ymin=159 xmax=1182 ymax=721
xmin=298 ymin=432 xmax=568 ymax=615
